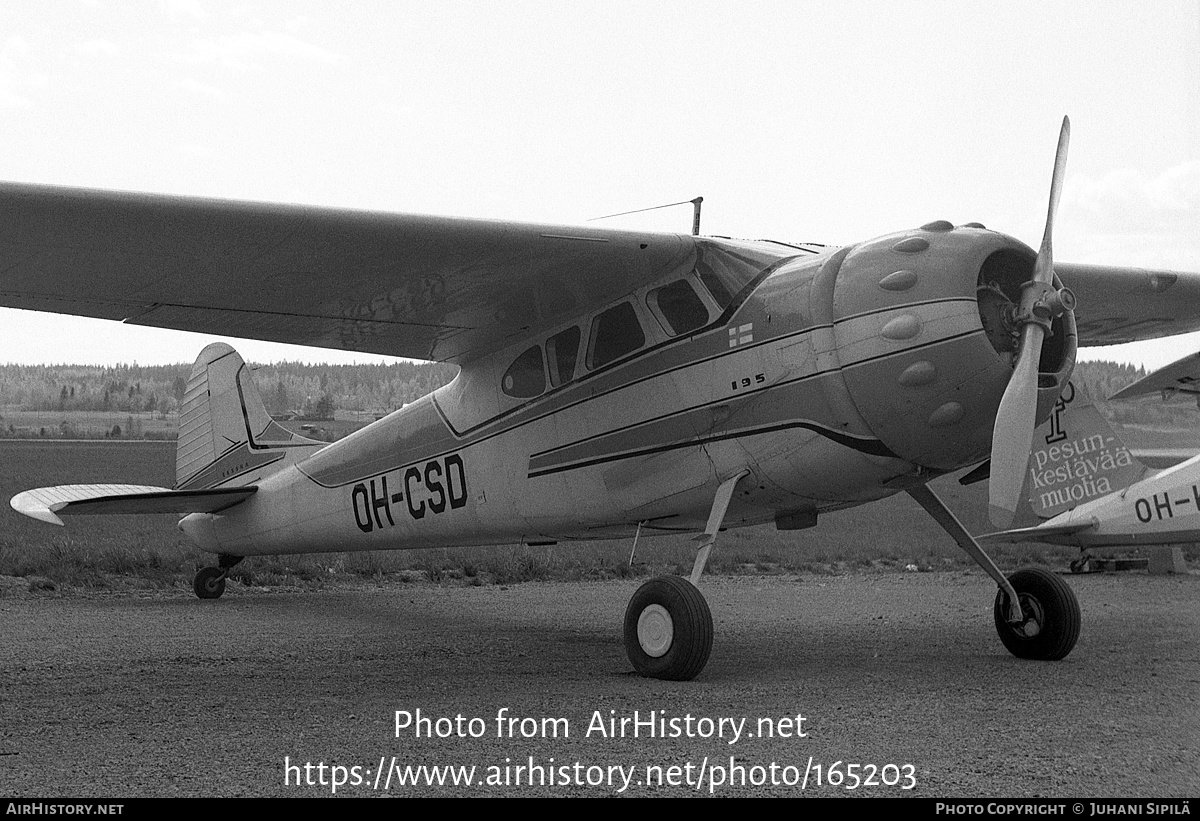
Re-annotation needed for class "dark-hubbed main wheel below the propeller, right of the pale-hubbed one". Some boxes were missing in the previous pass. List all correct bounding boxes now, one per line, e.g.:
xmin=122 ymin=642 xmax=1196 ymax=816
xmin=995 ymin=568 xmax=1082 ymax=661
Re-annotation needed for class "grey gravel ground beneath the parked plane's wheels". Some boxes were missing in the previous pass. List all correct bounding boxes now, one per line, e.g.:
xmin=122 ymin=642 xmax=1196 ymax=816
xmin=0 ymin=571 xmax=1200 ymax=798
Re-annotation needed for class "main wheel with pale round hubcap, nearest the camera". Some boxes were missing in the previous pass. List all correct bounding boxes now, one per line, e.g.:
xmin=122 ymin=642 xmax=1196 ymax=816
xmin=625 ymin=576 xmax=713 ymax=682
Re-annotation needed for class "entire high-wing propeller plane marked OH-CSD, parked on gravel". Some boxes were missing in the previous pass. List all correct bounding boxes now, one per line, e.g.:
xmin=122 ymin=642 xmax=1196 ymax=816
xmin=0 ymin=120 xmax=1200 ymax=679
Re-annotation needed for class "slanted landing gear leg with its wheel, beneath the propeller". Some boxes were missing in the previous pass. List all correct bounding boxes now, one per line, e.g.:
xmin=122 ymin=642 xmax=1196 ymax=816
xmin=908 ymin=485 xmax=1081 ymax=661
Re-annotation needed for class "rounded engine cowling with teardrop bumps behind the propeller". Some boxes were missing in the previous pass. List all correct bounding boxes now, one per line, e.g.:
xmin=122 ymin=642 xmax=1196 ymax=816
xmin=812 ymin=222 xmax=1076 ymax=471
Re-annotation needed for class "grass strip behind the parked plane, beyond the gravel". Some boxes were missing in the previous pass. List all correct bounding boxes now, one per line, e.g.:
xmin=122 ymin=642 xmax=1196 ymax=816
xmin=0 ymin=439 xmax=1196 ymax=588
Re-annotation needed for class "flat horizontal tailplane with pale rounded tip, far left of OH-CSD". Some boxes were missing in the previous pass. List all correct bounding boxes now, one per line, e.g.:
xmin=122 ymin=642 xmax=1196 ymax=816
xmin=11 ymin=485 xmax=258 ymax=526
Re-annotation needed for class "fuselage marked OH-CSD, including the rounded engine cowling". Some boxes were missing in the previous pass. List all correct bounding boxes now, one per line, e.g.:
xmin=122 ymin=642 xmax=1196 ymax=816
xmin=184 ymin=223 xmax=1075 ymax=556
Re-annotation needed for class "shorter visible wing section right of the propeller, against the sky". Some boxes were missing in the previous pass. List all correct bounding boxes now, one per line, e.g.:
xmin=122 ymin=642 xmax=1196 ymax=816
xmin=1055 ymin=263 xmax=1200 ymax=346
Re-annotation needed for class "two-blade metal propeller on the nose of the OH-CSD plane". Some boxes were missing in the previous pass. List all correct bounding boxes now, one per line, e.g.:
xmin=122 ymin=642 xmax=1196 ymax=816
xmin=988 ymin=116 xmax=1074 ymax=528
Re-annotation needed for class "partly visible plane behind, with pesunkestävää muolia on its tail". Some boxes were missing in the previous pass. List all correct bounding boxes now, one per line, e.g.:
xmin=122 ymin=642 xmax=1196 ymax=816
xmin=979 ymin=354 xmax=1200 ymax=556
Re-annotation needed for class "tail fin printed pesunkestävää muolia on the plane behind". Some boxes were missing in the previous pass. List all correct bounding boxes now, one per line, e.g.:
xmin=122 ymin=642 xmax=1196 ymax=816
xmin=1030 ymin=382 xmax=1150 ymax=519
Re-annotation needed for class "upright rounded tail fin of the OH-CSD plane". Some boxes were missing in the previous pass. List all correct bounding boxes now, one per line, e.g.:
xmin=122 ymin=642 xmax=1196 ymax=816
xmin=175 ymin=342 xmax=325 ymax=490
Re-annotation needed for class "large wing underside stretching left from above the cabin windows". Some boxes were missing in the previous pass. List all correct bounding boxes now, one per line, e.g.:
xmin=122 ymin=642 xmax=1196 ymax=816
xmin=0 ymin=184 xmax=696 ymax=361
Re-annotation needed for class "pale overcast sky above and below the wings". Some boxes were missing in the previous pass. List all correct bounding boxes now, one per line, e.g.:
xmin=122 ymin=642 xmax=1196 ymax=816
xmin=0 ymin=0 xmax=1200 ymax=366
